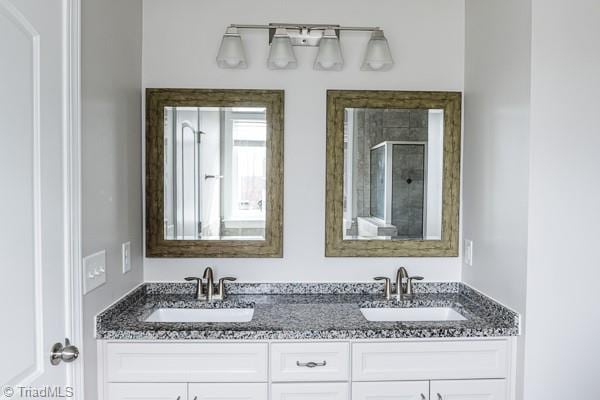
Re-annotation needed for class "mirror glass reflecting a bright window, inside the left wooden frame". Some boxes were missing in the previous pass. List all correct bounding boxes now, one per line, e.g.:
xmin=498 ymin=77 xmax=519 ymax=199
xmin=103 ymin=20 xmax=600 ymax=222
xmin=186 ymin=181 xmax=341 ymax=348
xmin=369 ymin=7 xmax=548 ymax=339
xmin=163 ymin=107 xmax=267 ymax=240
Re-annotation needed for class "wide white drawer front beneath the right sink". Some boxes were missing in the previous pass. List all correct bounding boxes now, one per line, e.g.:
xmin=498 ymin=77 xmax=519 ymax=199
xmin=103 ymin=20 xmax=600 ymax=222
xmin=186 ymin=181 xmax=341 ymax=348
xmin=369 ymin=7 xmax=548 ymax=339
xmin=352 ymin=340 xmax=510 ymax=381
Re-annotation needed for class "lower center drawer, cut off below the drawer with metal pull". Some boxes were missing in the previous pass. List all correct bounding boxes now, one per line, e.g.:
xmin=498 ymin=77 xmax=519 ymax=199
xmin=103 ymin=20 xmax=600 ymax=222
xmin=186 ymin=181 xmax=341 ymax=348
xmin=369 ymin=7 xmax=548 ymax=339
xmin=271 ymin=383 xmax=348 ymax=400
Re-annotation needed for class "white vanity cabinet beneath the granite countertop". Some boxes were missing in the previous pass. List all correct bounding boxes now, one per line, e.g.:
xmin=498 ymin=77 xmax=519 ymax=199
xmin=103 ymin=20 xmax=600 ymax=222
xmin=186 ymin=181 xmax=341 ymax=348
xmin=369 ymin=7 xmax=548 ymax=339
xmin=98 ymin=337 xmax=516 ymax=400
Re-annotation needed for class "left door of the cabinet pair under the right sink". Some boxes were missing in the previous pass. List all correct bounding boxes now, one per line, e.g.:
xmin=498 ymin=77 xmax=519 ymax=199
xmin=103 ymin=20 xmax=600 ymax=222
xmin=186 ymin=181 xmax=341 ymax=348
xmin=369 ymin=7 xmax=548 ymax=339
xmin=352 ymin=381 xmax=428 ymax=400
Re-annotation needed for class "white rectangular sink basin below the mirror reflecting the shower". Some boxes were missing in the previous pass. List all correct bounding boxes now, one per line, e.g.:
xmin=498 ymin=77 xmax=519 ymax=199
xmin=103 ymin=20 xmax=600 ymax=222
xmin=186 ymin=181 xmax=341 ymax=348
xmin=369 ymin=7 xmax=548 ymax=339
xmin=360 ymin=307 xmax=466 ymax=321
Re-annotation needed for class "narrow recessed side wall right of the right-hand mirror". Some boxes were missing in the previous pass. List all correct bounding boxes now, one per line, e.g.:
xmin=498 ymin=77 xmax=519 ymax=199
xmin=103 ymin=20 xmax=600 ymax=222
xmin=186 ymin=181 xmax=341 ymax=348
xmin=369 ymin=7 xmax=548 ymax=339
xmin=463 ymin=0 xmax=534 ymax=398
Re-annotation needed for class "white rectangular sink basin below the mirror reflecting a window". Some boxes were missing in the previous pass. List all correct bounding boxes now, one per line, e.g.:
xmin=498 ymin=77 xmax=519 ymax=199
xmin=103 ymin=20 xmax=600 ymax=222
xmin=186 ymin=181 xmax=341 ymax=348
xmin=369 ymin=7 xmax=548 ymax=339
xmin=146 ymin=308 xmax=254 ymax=322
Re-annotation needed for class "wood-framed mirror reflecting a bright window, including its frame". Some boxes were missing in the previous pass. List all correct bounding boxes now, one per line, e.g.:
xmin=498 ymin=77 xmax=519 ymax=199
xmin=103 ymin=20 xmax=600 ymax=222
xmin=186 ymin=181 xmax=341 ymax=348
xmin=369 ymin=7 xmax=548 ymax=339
xmin=146 ymin=89 xmax=284 ymax=257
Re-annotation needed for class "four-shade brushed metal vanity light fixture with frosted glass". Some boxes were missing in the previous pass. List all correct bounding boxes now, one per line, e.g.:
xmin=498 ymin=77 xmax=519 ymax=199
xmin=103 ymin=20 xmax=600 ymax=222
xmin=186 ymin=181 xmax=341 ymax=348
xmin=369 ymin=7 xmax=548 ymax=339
xmin=217 ymin=23 xmax=394 ymax=71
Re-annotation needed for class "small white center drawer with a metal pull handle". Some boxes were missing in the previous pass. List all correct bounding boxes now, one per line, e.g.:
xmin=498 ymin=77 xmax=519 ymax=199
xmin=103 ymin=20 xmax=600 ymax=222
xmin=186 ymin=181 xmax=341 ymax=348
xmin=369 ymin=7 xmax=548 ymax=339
xmin=271 ymin=342 xmax=350 ymax=382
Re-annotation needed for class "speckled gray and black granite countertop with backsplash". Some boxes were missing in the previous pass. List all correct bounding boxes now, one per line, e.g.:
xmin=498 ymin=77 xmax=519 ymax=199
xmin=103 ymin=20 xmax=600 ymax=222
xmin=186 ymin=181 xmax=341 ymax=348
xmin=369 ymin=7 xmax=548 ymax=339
xmin=96 ymin=282 xmax=519 ymax=340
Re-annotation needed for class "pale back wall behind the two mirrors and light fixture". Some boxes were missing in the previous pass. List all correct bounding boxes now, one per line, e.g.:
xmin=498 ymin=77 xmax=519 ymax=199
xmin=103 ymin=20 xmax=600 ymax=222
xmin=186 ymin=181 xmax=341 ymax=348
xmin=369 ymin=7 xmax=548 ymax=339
xmin=143 ymin=0 xmax=464 ymax=281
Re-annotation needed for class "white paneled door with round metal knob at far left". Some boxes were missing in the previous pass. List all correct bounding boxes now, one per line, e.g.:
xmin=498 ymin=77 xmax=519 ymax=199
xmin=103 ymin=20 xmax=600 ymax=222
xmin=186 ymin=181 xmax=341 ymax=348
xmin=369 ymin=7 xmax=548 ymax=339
xmin=0 ymin=0 xmax=78 ymax=398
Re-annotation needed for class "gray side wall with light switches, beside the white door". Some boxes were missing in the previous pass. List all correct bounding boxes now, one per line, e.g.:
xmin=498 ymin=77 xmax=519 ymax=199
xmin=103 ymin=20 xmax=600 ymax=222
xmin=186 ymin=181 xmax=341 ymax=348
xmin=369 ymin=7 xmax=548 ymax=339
xmin=81 ymin=0 xmax=143 ymax=400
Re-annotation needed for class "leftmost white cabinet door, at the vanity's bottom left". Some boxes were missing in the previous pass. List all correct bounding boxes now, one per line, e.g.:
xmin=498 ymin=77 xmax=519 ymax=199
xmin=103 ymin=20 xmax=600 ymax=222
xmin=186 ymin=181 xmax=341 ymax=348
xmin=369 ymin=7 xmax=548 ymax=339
xmin=108 ymin=383 xmax=187 ymax=400
